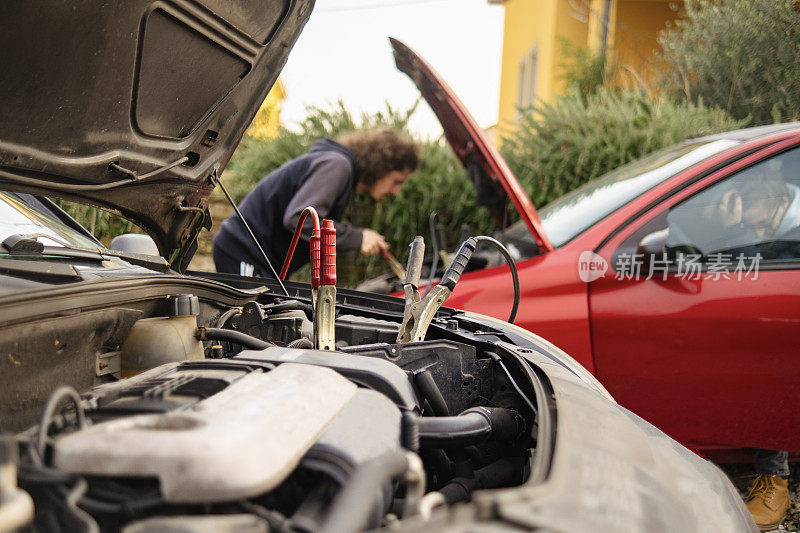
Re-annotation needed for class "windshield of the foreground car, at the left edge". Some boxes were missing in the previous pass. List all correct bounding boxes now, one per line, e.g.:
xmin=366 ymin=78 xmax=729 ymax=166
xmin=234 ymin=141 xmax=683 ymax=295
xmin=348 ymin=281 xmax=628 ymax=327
xmin=0 ymin=191 xmax=103 ymax=250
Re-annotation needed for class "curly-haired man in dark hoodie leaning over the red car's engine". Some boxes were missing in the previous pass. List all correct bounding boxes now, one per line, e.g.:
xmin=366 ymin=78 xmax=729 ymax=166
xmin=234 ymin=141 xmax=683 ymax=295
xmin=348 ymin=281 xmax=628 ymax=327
xmin=214 ymin=127 xmax=419 ymax=276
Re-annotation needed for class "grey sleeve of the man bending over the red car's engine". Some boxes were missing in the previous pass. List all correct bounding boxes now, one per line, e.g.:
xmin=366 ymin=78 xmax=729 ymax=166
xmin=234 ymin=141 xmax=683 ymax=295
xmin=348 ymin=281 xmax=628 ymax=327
xmin=283 ymin=154 xmax=363 ymax=251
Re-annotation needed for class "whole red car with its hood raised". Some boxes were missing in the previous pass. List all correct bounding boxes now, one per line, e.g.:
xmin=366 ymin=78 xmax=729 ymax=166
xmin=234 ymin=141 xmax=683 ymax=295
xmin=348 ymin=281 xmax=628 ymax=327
xmin=394 ymin=43 xmax=800 ymax=458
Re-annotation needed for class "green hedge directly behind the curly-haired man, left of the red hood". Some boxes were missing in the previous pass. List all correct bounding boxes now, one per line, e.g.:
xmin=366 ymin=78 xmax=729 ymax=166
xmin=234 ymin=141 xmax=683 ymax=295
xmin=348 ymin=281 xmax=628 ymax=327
xmin=222 ymin=102 xmax=494 ymax=285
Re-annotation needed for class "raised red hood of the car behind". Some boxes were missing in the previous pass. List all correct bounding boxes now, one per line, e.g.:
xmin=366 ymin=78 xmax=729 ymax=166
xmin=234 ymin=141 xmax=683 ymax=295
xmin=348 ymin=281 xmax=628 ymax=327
xmin=389 ymin=38 xmax=553 ymax=251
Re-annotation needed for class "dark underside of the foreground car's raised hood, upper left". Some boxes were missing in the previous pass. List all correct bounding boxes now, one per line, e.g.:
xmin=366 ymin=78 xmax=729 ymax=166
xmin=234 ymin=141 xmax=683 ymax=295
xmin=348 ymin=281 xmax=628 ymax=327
xmin=0 ymin=0 xmax=314 ymax=270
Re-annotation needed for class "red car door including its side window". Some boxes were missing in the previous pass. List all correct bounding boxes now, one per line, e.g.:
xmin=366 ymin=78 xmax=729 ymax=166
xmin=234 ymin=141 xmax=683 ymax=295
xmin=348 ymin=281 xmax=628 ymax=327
xmin=589 ymin=138 xmax=800 ymax=452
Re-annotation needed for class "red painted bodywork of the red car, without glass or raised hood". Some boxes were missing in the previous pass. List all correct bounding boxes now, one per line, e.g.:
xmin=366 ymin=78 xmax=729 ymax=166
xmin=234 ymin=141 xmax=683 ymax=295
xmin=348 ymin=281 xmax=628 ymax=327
xmin=448 ymin=128 xmax=800 ymax=457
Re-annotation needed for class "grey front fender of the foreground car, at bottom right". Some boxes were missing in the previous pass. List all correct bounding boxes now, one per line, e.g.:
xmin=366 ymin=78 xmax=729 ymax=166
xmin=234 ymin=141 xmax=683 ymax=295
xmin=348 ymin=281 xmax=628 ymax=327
xmin=487 ymin=364 xmax=757 ymax=533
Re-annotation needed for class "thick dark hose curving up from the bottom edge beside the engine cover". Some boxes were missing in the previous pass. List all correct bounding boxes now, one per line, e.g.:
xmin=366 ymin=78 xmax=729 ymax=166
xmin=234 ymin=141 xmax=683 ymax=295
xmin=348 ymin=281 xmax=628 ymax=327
xmin=320 ymin=452 xmax=408 ymax=533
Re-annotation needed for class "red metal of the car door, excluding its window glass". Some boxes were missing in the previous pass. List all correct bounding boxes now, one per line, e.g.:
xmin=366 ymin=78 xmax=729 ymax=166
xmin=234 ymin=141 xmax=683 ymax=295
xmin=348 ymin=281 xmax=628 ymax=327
xmin=590 ymin=137 xmax=800 ymax=452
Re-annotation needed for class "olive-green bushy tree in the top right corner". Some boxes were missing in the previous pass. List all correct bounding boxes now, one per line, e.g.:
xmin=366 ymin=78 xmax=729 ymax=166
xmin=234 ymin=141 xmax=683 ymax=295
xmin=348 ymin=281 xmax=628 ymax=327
xmin=660 ymin=0 xmax=800 ymax=124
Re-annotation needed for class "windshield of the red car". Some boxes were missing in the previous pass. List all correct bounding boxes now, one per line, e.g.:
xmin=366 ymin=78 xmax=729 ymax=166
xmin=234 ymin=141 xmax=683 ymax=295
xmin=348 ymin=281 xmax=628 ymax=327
xmin=505 ymin=139 xmax=739 ymax=248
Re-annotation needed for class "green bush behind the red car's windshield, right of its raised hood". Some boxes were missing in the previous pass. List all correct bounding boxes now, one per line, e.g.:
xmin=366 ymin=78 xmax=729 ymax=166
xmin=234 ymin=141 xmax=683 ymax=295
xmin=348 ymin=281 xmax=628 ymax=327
xmin=502 ymin=88 xmax=742 ymax=207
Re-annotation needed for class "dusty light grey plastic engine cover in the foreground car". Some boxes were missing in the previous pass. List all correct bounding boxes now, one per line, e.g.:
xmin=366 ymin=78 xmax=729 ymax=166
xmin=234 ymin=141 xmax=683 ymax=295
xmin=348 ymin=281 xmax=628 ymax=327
xmin=53 ymin=362 xmax=357 ymax=503
